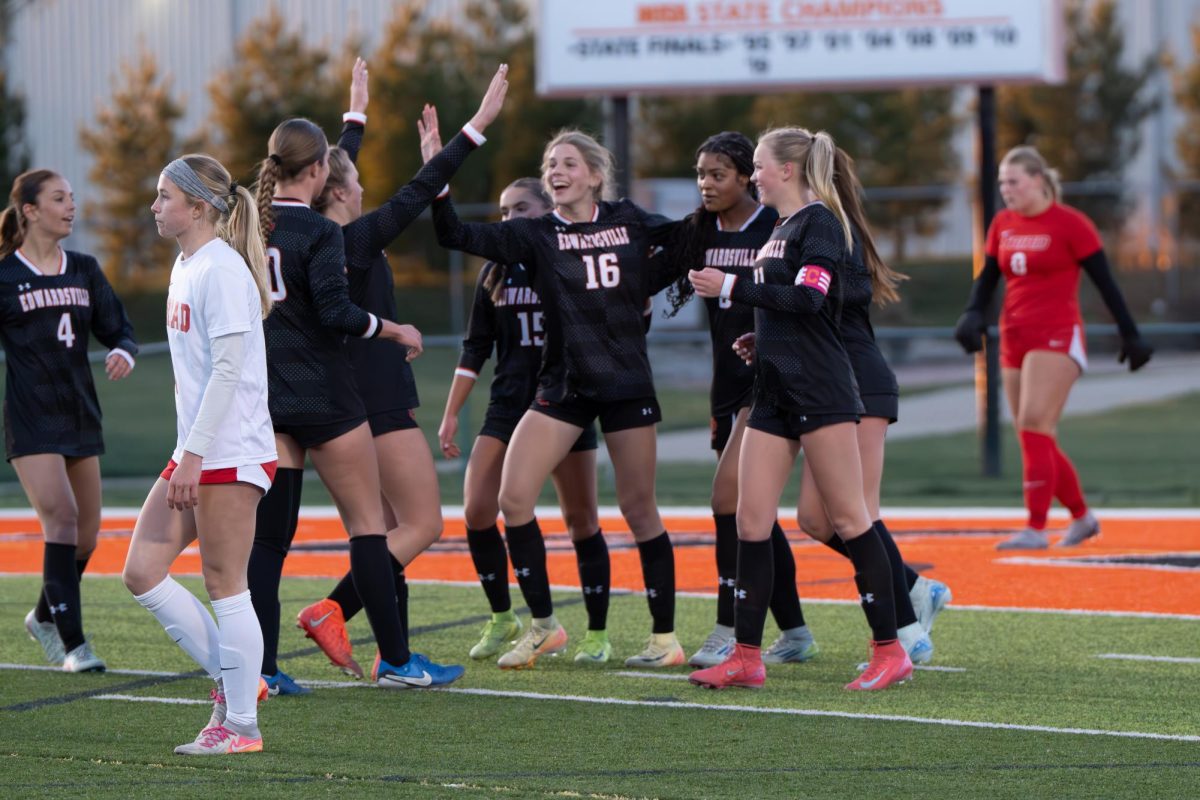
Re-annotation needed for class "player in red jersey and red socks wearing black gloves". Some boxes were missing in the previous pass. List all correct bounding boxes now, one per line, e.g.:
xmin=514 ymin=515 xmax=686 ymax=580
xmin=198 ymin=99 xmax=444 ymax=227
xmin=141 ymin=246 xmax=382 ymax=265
xmin=954 ymin=146 xmax=1153 ymax=549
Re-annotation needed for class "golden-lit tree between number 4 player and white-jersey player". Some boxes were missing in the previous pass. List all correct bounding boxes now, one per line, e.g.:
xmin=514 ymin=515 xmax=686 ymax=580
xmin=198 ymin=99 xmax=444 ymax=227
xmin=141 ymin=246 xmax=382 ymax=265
xmin=79 ymin=52 xmax=182 ymax=289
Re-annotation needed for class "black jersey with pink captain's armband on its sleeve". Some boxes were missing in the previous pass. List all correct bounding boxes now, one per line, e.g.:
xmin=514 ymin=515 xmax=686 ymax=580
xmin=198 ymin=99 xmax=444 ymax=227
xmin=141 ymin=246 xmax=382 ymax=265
xmin=721 ymin=203 xmax=863 ymax=414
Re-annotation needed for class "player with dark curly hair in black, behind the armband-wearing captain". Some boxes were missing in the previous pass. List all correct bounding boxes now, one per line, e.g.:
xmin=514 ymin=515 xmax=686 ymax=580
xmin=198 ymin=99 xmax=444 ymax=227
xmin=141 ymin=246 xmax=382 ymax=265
xmin=661 ymin=136 xmax=817 ymax=667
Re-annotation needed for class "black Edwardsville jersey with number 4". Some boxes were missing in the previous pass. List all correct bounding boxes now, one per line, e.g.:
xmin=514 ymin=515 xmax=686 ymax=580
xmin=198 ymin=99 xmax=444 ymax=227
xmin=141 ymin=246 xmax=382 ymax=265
xmin=0 ymin=251 xmax=138 ymax=458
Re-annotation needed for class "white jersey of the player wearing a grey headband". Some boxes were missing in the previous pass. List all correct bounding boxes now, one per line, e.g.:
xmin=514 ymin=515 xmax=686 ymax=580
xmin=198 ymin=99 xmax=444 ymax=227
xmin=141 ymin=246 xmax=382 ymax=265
xmin=167 ymin=239 xmax=276 ymax=470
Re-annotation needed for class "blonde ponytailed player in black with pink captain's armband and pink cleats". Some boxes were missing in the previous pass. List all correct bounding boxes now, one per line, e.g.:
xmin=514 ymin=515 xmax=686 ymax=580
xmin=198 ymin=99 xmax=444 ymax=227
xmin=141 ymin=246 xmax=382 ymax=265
xmin=689 ymin=128 xmax=912 ymax=690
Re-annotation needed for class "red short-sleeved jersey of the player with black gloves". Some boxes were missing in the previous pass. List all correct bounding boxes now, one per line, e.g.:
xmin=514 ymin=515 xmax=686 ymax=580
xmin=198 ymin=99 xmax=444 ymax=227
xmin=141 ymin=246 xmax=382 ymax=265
xmin=985 ymin=208 xmax=1103 ymax=329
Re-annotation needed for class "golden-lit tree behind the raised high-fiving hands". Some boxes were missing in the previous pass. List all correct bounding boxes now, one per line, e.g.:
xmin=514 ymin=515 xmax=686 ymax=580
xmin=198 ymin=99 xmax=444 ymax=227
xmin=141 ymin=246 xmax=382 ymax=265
xmin=352 ymin=0 xmax=599 ymax=282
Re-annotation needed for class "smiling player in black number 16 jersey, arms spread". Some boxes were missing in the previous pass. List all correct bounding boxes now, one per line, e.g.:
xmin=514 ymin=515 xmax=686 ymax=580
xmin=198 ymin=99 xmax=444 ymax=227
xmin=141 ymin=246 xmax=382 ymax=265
xmin=424 ymin=120 xmax=685 ymax=669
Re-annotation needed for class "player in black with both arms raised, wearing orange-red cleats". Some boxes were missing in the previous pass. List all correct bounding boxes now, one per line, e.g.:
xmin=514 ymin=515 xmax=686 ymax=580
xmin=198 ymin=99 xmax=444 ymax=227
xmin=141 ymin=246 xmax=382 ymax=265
xmin=296 ymin=59 xmax=494 ymax=678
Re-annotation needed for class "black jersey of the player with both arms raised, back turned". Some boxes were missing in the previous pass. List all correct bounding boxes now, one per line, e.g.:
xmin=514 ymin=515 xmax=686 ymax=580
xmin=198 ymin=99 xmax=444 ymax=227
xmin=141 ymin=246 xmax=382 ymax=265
xmin=337 ymin=120 xmax=475 ymax=414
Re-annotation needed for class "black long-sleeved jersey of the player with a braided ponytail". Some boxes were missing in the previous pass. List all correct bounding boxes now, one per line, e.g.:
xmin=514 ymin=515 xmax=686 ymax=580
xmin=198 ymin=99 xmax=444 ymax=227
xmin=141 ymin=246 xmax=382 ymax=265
xmin=264 ymin=198 xmax=379 ymax=426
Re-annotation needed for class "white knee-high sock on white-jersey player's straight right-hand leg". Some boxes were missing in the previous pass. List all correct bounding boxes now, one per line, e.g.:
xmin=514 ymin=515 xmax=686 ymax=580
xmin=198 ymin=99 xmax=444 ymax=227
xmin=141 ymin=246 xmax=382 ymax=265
xmin=212 ymin=590 xmax=263 ymax=735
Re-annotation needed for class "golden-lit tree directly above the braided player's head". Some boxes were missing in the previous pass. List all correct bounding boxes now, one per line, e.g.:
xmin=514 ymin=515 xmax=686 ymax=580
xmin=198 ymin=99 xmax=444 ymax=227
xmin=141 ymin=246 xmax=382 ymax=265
xmin=209 ymin=5 xmax=350 ymax=185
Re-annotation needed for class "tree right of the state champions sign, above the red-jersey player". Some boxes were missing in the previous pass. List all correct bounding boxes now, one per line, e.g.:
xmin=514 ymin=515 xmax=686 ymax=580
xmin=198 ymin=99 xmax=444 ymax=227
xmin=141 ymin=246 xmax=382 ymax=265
xmin=996 ymin=0 xmax=1163 ymax=229
